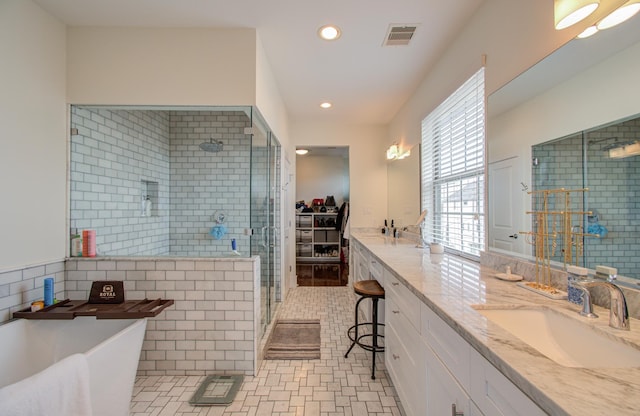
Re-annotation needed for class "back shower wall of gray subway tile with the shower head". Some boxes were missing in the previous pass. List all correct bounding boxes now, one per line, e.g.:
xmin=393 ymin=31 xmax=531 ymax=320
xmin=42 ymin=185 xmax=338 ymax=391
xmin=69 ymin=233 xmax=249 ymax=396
xmin=169 ymin=111 xmax=252 ymax=257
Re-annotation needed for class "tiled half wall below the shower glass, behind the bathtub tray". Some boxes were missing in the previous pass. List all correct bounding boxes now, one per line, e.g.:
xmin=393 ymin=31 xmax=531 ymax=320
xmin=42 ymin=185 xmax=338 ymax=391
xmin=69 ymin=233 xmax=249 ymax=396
xmin=66 ymin=257 xmax=262 ymax=375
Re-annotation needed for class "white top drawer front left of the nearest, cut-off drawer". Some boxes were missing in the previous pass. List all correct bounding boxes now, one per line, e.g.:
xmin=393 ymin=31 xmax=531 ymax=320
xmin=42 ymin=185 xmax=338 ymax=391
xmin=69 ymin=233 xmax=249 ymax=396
xmin=420 ymin=303 xmax=471 ymax=391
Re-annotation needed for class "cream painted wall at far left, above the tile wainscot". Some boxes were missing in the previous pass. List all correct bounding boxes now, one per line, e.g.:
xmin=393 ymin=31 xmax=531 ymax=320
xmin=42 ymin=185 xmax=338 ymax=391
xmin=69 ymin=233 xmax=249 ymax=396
xmin=0 ymin=0 xmax=68 ymax=272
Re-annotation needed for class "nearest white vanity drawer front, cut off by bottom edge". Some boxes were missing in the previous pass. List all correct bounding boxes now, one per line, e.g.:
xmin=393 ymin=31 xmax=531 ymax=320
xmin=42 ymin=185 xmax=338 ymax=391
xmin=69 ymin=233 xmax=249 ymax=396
xmin=470 ymin=349 xmax=546 ymax=416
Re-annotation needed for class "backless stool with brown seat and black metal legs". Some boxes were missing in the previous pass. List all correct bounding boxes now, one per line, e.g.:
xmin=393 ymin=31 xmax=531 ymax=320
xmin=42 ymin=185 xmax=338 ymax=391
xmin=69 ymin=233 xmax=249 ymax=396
xmin=344 ymin=280 xmax=384 ymax=380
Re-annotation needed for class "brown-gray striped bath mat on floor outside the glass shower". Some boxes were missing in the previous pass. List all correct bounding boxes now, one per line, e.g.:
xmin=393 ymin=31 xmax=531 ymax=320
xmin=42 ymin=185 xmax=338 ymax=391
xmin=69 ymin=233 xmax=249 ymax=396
xmin=264 ymin=319 xmax=320 ymax=360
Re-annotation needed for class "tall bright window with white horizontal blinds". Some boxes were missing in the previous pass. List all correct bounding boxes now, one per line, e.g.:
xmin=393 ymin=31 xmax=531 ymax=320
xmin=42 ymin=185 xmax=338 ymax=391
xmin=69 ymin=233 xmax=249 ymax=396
xmin=421 ymin=68 xmax=485 ymax=256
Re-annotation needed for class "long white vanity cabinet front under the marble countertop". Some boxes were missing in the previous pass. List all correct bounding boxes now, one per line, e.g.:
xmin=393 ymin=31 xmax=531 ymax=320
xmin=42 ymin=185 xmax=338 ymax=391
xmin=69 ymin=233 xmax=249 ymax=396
xmin=358 ymin=242 xmax=546 ymax=416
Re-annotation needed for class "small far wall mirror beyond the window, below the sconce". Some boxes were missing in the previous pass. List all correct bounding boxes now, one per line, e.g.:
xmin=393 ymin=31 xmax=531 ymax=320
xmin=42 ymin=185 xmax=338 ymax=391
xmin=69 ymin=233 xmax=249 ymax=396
xmin=387 ymin=144 xmax=420 ymax=228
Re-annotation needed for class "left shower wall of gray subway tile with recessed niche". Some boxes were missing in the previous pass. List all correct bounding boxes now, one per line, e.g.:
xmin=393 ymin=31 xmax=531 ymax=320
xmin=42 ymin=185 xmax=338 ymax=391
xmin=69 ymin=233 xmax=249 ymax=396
xmin=70 ymin=106 xmax=170 ymax=255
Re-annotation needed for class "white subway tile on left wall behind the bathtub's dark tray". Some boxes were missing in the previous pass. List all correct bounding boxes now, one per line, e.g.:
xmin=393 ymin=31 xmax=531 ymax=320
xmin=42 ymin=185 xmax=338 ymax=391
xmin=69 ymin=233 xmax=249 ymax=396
xmin=0 ymin=261 xmax=65 ymax=323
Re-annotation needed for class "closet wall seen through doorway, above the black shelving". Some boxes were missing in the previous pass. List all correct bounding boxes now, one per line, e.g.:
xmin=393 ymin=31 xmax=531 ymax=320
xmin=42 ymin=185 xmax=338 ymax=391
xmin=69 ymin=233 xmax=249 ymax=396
xmin=296 ymin=154 xmax=349 ymax=207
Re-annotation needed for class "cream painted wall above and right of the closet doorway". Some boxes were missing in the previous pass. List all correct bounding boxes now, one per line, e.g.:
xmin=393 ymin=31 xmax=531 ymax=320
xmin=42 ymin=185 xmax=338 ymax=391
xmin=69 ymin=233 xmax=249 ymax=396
xmin=290 ymin=121 xmax=387 ymax=227
